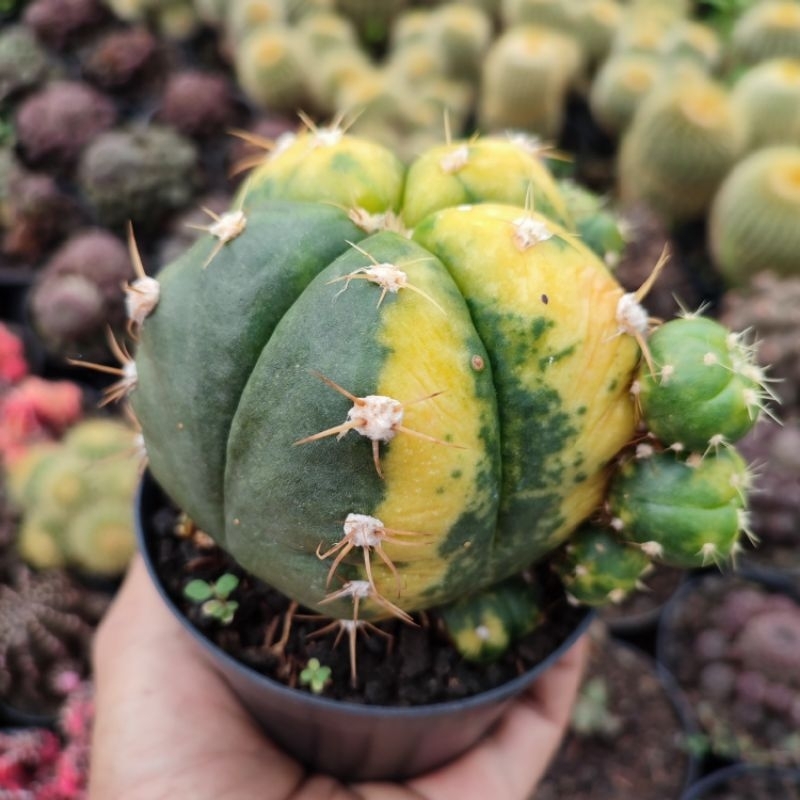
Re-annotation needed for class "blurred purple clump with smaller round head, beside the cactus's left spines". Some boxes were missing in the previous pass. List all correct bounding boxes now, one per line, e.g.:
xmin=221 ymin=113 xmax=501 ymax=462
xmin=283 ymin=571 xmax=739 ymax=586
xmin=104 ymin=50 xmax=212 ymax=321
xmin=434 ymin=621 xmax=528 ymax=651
xmin=29 ymin=229 xmax=134 ymax=358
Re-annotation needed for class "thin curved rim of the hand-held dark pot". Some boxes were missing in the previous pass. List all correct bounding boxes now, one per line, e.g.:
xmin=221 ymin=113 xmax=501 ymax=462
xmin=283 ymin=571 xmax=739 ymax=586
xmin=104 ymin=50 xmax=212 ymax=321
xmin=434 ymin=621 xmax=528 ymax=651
xmin=134 ymin=470 xmax=596 ymax=719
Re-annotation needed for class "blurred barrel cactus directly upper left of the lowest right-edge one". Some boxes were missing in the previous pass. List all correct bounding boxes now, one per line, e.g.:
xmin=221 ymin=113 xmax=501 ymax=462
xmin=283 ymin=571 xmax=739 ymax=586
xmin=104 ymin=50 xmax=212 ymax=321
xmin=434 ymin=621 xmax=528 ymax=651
xmin=618 ymin=68 xmax=746 ymax=222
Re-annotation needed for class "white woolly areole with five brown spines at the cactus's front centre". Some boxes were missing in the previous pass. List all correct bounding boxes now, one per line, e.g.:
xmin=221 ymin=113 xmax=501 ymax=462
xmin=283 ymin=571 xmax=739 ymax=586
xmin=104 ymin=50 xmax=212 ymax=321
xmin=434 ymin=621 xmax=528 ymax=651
xmin=294 ymin=372 xmax=460 ymax=478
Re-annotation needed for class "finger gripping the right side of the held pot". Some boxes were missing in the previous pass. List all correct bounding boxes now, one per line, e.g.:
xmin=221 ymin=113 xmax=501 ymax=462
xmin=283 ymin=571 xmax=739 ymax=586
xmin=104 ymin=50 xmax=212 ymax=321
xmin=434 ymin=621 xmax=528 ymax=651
xmin=409 ymin=636 xmax=588 ymax=800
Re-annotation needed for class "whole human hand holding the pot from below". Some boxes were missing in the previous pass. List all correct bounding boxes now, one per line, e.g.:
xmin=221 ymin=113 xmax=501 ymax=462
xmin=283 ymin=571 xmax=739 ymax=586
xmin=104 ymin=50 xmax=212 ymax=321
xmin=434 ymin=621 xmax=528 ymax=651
xmin=89 ymin=558 xmax=587 ymax=800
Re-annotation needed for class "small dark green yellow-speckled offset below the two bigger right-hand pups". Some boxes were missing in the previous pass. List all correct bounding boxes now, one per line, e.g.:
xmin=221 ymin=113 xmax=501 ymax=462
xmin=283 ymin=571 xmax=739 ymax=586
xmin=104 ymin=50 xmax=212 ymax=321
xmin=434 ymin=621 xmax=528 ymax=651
xmin=555 ymin=524 xmax=652 ymax=606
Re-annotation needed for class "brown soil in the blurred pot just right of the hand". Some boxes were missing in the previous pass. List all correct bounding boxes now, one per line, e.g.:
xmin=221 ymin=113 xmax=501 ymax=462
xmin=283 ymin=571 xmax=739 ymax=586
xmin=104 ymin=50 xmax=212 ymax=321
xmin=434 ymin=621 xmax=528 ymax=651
xmin=534 ymin=638 xmax=691 ymax=800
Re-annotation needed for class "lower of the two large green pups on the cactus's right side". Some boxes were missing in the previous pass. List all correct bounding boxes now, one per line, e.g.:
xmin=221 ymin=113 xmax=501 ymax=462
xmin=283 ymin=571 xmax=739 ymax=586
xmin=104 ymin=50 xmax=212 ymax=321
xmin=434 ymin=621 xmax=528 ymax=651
xmin=609 ymin=448 xmax=748 ymax=568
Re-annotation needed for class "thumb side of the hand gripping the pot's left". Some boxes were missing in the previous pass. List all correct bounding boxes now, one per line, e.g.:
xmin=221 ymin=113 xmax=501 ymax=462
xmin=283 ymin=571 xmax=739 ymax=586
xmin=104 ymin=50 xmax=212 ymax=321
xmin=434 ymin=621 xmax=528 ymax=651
xmin=89 ymin=558 xmax=310 ymax=800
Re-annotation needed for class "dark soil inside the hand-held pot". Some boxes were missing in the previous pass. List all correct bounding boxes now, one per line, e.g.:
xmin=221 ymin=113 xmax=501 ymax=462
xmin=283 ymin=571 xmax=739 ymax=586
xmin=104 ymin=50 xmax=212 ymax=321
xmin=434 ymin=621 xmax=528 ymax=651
xmin=144 ymin=478 xmax=587 ymax=706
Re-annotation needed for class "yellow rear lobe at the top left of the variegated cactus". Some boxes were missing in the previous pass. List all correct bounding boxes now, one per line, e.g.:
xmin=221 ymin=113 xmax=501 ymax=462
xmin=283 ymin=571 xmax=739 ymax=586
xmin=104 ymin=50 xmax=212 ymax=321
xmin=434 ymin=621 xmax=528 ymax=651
xmin=242 ymin=129 xmax=405 ymax=214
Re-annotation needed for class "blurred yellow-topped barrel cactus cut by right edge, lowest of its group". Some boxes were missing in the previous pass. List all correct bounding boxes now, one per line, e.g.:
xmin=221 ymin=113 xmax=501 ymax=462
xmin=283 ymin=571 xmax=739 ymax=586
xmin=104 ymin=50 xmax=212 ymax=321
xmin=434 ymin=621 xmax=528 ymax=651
xmin=709 ymin=145 xmax=800 ymax=286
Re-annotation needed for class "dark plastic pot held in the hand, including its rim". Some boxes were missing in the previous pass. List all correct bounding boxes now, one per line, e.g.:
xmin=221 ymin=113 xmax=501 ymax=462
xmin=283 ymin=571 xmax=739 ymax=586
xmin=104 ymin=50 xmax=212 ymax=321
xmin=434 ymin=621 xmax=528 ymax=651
xmin=135 ymin=473 xmax=594 ymax=780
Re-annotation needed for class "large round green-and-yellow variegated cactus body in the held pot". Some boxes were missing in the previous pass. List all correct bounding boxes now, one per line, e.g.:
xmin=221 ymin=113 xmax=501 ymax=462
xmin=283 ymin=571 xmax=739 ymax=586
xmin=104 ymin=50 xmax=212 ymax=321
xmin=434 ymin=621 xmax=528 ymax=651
xmin=122 ymin=128 xmax=764 ymax=658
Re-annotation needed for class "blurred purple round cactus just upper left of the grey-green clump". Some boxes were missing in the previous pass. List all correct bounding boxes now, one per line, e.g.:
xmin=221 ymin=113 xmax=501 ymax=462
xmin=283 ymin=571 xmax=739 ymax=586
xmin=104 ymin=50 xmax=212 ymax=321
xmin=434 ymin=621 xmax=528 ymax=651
xmin=15 ymin=81 xmax=117 ymax=166
